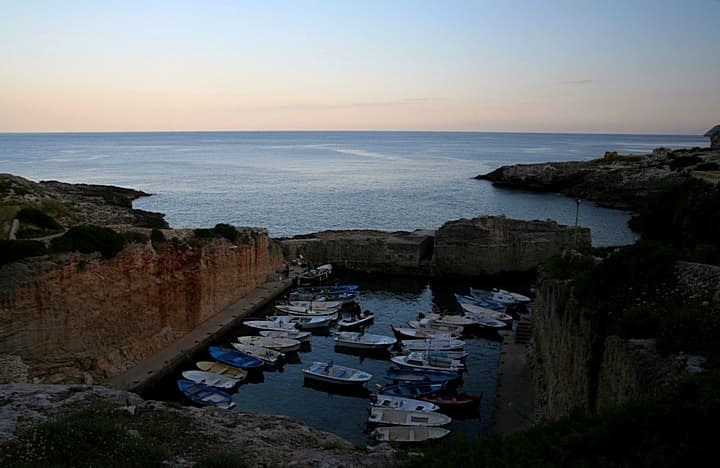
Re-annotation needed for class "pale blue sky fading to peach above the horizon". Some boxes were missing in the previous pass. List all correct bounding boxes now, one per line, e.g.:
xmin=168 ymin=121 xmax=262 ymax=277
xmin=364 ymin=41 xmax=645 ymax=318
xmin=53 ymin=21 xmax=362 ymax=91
xmin=0 ymin=0 xmax=720 ymax=135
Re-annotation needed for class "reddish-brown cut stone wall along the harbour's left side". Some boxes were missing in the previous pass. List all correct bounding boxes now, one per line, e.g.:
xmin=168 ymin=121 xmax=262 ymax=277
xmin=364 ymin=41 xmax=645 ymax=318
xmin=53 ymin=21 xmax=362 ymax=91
xmin=0 ymin=230 xmax=283 ymax=383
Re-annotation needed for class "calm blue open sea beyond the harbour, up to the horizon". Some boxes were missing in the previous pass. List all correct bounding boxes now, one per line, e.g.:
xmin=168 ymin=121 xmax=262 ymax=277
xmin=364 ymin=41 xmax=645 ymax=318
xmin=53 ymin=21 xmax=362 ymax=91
xmin=0 ymin=132 xmax=707 ymax=245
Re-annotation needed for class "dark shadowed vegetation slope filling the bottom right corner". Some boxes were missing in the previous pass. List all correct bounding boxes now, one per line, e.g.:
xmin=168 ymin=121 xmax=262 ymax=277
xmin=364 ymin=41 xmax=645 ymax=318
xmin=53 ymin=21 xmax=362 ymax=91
xmin=408 ymin=372 xmax=720 ymax=468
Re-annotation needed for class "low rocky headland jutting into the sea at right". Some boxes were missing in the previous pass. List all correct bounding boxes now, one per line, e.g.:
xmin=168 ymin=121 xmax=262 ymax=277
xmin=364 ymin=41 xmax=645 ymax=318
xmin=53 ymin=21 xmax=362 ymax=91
xmin=475 ymin=148 xmax=720 ymax=209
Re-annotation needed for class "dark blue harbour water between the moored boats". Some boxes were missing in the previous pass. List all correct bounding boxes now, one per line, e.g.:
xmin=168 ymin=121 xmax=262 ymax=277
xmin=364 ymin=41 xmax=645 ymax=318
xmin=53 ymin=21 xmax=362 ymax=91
xmin=143 ymin=277 xmax=529 ymax=444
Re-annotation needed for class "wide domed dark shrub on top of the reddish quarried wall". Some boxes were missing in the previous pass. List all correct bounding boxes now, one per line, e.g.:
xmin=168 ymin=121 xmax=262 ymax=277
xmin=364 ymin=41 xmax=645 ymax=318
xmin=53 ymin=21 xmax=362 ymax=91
xmin=51 ymin=224 xmax=125 ymax=259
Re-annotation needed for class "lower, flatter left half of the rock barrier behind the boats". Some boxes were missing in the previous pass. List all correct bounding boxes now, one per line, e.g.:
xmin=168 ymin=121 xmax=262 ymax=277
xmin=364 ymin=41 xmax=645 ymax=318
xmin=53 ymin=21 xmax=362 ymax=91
xmin=280 ymin=230 xmax=435 ymax=275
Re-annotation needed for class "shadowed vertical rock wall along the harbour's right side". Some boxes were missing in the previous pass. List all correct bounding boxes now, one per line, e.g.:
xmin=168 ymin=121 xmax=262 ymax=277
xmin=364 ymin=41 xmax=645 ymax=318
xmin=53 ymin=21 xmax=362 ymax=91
xmin=528 ymin=267 xmax=704 ymax=421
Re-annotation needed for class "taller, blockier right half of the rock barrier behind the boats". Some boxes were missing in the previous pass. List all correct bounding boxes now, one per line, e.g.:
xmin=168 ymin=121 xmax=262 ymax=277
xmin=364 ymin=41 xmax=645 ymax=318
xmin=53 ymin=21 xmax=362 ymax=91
xmin=433 ymin=216 xmax=591 ymax=276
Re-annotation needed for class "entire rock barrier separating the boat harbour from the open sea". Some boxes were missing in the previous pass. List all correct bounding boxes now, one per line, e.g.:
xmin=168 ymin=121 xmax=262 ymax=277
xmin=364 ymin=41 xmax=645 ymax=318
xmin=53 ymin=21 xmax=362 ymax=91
xmin=280 ymin=216 xmax=590 ymax=276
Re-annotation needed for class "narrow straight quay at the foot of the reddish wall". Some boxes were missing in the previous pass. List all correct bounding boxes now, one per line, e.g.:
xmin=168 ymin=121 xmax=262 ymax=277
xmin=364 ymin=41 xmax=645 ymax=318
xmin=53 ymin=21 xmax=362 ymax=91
xmin=107 ymin=267 xmax=302 ymax=392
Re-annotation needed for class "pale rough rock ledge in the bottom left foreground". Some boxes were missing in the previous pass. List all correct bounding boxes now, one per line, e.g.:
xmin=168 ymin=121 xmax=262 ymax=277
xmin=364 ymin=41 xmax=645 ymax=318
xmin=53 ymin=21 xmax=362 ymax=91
xmin=0 ymin=385 xmax=398 ymax=467
